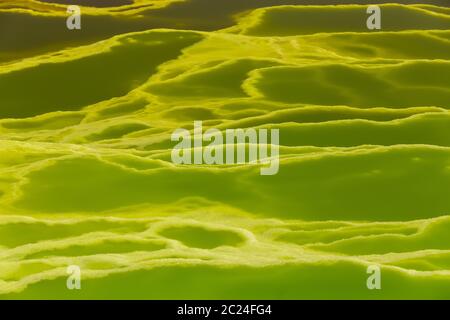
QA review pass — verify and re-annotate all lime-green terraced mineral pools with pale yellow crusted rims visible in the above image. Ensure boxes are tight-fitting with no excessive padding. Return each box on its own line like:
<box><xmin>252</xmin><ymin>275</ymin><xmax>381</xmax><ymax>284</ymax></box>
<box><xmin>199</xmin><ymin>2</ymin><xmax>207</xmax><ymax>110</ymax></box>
<box><xmin>0</xmin><ymin>0</ymin><xmax>450</xmax><ymax>299</ymax></box>
